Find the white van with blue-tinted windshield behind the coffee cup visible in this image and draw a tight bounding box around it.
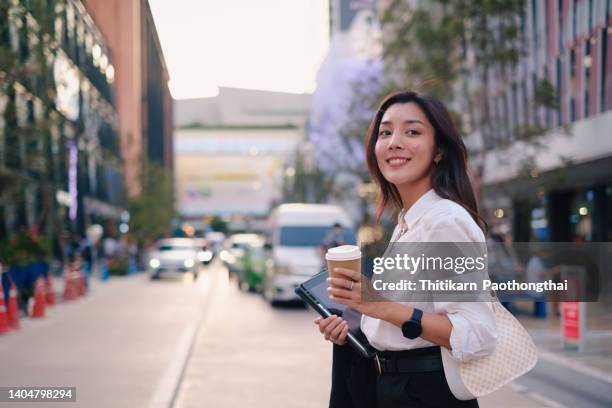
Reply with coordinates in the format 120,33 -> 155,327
263,204 -> 356,304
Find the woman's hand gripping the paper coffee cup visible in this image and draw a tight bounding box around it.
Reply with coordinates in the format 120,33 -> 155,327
327,268 -> 394,319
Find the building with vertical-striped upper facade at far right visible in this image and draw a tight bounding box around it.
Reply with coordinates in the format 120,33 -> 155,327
468,0 -> 612,242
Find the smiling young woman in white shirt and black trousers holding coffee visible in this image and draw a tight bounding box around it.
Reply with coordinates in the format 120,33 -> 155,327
315,92 -> 497,408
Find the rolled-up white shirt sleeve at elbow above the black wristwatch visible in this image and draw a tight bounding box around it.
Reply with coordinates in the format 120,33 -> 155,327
435,302 -> 497,362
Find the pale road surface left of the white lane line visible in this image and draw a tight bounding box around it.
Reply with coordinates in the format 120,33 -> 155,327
0,266 -> 206,407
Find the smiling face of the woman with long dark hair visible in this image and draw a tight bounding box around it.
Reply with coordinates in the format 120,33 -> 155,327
374,102 -> 439,186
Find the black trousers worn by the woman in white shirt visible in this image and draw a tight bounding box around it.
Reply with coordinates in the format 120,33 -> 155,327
329,345 -> 478,408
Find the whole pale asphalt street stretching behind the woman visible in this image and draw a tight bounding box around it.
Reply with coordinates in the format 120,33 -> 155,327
0,262 -> 609,408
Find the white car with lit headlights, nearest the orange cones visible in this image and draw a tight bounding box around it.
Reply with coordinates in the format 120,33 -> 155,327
147,238 -> 202,279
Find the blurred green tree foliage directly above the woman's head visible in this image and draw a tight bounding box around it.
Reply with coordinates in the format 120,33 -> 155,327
382,0 -> 525,124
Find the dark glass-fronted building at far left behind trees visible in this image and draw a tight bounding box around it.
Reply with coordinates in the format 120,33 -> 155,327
0,0 -> 127,239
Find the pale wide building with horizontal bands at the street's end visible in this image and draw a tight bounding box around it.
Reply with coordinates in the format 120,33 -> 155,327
174,87 -> 311,230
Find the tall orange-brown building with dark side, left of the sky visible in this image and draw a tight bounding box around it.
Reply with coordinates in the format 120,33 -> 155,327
85,0 -> 174,197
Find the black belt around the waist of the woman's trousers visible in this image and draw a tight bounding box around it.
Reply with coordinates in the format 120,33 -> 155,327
374,346 -> 444,374
